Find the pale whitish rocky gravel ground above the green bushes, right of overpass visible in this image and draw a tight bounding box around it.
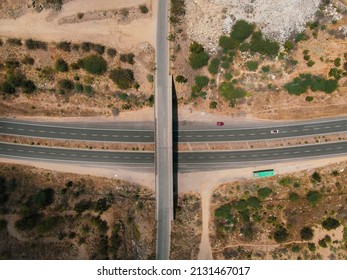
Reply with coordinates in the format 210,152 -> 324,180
186,0 -> 321,52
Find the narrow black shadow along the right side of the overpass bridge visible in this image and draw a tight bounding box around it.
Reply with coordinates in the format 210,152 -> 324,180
172,76 -> 179,219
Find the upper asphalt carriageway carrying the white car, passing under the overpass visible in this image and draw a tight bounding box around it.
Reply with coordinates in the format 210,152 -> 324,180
0,119 -> 347,143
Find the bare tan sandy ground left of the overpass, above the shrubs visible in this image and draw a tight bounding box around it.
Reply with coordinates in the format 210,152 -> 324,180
0,0 -> 157,49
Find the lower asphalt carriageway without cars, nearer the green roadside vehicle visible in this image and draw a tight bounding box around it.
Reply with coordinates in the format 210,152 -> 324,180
0,141 -> 347,172
